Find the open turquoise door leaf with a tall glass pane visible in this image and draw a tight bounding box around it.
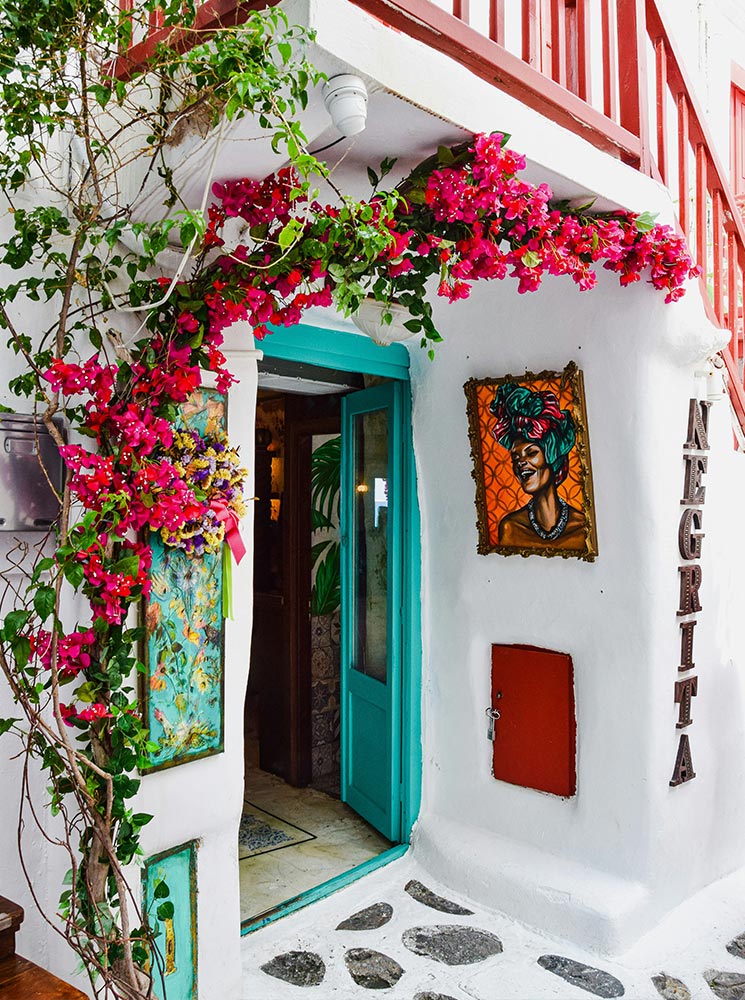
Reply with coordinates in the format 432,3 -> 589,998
341,382 -> 405,842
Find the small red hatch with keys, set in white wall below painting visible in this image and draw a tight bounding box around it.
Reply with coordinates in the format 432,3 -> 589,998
492,645 -> 577,797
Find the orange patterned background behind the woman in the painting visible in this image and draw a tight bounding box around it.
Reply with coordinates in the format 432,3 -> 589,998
473,375 -> 585,548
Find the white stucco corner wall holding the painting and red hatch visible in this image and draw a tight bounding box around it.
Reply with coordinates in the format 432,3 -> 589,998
404,264 -> 745,952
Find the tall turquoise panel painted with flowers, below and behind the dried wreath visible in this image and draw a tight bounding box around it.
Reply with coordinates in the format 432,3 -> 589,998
141,389 -> 227,772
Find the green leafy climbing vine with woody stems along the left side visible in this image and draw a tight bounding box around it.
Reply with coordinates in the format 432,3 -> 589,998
0,0 -> 332,1000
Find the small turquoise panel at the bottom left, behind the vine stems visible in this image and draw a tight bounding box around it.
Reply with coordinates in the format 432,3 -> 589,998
142,841 -> 197,1000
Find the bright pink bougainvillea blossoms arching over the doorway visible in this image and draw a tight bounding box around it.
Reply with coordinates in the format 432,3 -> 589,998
36,134 -> 698,724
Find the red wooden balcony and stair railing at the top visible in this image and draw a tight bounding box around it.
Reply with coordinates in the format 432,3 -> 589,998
118,0 -> 745,432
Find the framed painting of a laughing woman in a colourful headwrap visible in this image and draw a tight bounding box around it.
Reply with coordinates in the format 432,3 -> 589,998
463,362 -> 598,561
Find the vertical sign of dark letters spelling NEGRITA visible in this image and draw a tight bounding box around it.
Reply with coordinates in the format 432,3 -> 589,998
670,399 -> 711,785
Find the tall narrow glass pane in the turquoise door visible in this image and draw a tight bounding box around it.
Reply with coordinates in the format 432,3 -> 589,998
352,410 -> 388,684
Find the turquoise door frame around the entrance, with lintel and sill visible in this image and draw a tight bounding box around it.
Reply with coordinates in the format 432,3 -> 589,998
241,324 -> 422,934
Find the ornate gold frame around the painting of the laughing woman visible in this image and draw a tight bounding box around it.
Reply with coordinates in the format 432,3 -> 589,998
463,361 -> 598,562
